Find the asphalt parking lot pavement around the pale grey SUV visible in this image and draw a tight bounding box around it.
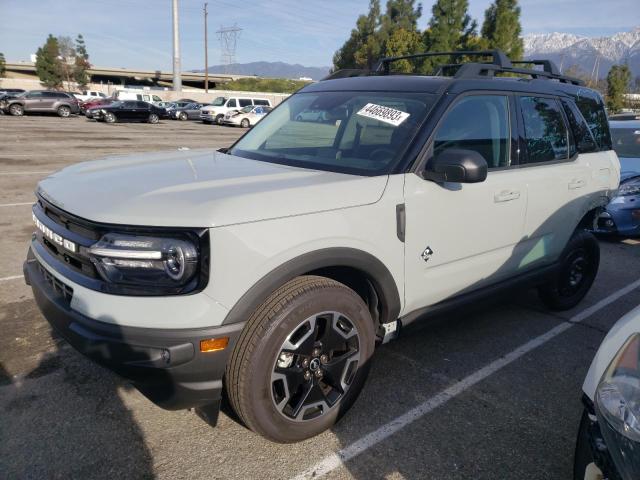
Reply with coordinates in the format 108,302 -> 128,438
0,116 -> 640,480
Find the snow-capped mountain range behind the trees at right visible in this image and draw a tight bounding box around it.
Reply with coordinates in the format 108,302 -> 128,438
523,26 -> 640,78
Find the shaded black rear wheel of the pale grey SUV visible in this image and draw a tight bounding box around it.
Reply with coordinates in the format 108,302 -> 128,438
538,230 -> 600,311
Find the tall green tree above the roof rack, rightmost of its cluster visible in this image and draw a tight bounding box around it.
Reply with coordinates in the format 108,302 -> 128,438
481,0 -> 524,60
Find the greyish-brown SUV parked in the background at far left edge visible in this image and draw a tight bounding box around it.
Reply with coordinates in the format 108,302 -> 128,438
0,90 -> 80,117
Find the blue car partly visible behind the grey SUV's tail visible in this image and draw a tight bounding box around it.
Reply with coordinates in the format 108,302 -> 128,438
595,120 -> 640,236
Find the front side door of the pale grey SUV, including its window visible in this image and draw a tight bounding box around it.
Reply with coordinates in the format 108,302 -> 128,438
405,93 -> 527,311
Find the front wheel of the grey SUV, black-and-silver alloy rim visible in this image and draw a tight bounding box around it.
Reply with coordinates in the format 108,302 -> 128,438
225,276 -> 375,443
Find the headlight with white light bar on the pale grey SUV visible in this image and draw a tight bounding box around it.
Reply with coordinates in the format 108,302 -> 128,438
88,233 -> 199,293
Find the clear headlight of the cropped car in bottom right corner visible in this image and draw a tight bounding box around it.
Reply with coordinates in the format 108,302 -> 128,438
596,334 -> 640,442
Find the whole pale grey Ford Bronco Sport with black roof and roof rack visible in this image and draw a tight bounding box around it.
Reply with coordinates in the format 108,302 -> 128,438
24,51 -> 620,442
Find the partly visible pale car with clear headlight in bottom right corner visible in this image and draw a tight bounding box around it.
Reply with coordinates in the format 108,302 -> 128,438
573,307 -> 640,480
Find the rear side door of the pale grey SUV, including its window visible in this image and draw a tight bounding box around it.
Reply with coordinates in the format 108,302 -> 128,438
516,94 -> 593,267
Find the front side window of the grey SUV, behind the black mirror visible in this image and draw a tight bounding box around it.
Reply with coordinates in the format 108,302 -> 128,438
433,95 -> 510,169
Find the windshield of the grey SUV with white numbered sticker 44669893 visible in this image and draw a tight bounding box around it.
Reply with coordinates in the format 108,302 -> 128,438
229,92 -> 433,175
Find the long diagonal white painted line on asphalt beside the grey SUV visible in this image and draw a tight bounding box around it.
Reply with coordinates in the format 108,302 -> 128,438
292,280 -> 640,480
